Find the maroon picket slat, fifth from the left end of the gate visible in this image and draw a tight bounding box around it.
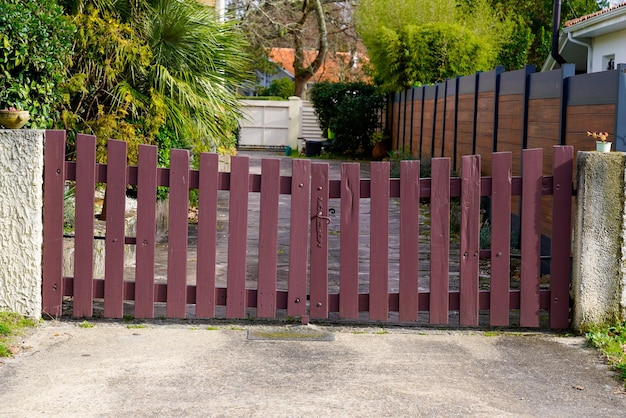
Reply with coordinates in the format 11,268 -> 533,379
167,149 -> 189,318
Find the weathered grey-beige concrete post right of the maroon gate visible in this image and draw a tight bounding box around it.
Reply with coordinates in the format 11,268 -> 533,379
572,152 -> 626,331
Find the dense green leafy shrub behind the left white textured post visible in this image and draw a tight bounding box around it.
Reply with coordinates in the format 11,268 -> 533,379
0,0 -> 75,128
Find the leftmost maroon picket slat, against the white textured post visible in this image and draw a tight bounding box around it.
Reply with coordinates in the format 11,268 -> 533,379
42,131 -> 65,318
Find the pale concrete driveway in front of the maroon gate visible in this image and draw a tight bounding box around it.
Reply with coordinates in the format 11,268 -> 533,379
0,321 -> 626,417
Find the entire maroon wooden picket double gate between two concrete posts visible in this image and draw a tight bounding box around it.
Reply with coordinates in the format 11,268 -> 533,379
43,131 -> 573,328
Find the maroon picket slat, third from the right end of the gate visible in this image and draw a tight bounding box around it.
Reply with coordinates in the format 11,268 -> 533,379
489,152 -> 512,326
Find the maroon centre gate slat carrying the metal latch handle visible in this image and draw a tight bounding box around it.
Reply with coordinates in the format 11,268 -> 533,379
309,163 -> 329,318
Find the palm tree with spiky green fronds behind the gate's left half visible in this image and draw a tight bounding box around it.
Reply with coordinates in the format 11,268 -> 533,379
63,0 -> 250,150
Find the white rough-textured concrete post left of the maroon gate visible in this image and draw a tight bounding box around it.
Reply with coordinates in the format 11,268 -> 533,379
0,129 -> 45,319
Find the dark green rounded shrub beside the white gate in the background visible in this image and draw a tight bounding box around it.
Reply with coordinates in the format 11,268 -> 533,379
311,82 -> 386,156
